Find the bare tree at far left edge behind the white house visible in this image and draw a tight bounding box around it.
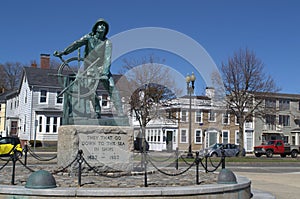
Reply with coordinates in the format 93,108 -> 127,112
0,62 -> 23,90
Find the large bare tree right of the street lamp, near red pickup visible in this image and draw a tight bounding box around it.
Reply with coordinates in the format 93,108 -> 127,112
221,48 -> 279,154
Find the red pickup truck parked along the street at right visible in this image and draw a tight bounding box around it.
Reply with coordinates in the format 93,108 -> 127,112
254,140 -> 299,158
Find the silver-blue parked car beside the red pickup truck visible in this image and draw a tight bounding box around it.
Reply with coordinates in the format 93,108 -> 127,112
200,143 -> 246,157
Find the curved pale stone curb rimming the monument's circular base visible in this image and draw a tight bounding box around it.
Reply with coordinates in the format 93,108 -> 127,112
0,177 -> 251,198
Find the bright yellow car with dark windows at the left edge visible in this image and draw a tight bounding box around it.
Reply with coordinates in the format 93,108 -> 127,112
0,137 -> 23,157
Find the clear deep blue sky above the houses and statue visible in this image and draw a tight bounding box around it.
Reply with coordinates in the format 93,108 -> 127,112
0,0 -> 300,94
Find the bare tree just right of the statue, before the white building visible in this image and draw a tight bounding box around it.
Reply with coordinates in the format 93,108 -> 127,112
122,55 -> 181,153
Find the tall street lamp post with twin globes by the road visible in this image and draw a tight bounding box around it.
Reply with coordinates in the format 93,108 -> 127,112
186,73 -> 196,158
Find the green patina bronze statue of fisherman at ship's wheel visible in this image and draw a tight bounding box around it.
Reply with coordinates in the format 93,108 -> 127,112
54,19 -> 123,125
